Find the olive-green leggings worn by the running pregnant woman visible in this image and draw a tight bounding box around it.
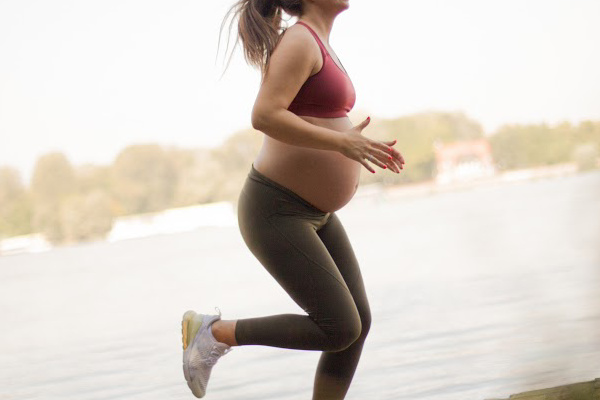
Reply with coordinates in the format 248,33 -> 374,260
235,165 -> 371,400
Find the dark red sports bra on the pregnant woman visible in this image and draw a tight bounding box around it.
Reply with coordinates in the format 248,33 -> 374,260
288,21 -> 356,118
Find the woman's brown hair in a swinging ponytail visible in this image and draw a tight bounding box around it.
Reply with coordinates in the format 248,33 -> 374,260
217,0 -> 303,77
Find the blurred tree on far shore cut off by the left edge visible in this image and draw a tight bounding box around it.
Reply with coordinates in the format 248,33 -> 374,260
0,166 -> 32,238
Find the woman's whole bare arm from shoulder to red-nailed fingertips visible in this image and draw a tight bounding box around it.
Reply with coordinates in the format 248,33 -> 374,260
252,26 -> 404,172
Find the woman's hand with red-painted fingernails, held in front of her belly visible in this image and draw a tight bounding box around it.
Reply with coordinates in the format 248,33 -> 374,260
339,117 -> 404,174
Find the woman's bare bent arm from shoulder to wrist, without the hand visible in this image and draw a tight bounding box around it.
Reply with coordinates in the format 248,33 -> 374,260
252,26 -> 344,151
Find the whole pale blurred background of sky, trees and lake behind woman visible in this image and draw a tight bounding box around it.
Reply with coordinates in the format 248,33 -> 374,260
0,0 -> 600,400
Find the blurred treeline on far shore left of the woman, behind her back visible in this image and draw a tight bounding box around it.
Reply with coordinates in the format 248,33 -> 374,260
0,130 -> 262,245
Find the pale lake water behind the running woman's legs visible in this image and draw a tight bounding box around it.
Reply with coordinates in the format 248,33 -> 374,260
0,171 -> 600,400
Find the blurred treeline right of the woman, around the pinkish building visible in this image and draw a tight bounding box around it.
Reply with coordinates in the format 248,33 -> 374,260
361,112 -> 600,185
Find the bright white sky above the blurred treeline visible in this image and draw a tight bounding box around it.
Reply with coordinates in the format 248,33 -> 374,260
0,0 -> 600,182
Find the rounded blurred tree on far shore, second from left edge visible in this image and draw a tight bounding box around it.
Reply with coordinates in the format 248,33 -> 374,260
31,152 -> 77,244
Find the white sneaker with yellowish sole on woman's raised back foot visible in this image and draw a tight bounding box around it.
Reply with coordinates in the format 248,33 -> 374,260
181,310 -> 231,398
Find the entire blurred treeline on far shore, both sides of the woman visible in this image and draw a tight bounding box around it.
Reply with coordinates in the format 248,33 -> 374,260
0,112 -> 600,244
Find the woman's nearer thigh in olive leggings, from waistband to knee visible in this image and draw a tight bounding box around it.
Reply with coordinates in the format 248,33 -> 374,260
238,178 -> 360,330
